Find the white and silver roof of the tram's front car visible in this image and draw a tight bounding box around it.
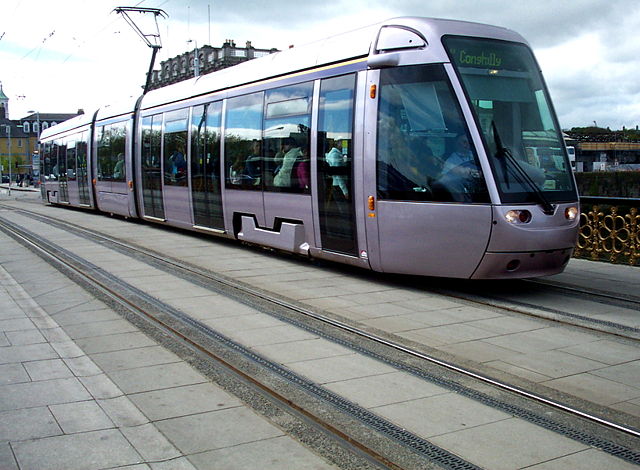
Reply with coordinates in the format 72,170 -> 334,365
142,17 -> 526,109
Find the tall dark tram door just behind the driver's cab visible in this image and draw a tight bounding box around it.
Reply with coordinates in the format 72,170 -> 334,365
317,74 -> 358,256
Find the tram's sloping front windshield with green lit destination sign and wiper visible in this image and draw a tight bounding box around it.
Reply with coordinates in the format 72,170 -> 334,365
444,36 -> 576,207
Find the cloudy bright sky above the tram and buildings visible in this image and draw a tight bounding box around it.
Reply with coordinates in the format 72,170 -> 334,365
0,0 -> 640,129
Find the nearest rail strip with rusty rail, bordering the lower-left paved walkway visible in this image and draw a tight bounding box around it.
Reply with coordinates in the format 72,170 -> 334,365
0,210 -> 479,470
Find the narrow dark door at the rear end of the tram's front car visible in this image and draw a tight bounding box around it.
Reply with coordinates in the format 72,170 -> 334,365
140,114 -> 164,220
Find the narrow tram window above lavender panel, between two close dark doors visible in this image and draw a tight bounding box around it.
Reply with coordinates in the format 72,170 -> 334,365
164,108 -> 189,186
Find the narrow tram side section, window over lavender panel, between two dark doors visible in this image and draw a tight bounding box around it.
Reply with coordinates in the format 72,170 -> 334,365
162,108 -> 192,226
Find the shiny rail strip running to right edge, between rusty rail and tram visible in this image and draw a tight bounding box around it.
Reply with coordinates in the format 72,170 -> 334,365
3,204 -> 640,468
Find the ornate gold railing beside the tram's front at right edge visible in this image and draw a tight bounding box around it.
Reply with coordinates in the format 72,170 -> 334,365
573,197 -> 640,266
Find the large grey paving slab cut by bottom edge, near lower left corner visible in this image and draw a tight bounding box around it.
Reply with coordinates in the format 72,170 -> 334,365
13,429 -> 143,470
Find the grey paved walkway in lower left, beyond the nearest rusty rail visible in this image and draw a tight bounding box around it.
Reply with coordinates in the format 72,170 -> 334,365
0,231 -> 333,470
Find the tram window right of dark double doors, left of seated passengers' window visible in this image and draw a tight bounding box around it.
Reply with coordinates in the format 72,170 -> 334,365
224,92 -> 264,190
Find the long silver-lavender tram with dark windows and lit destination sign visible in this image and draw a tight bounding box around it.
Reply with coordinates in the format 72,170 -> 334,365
41,17 -> 580,279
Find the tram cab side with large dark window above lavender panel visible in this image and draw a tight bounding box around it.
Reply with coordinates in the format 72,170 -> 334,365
363,65 -> 491,277
